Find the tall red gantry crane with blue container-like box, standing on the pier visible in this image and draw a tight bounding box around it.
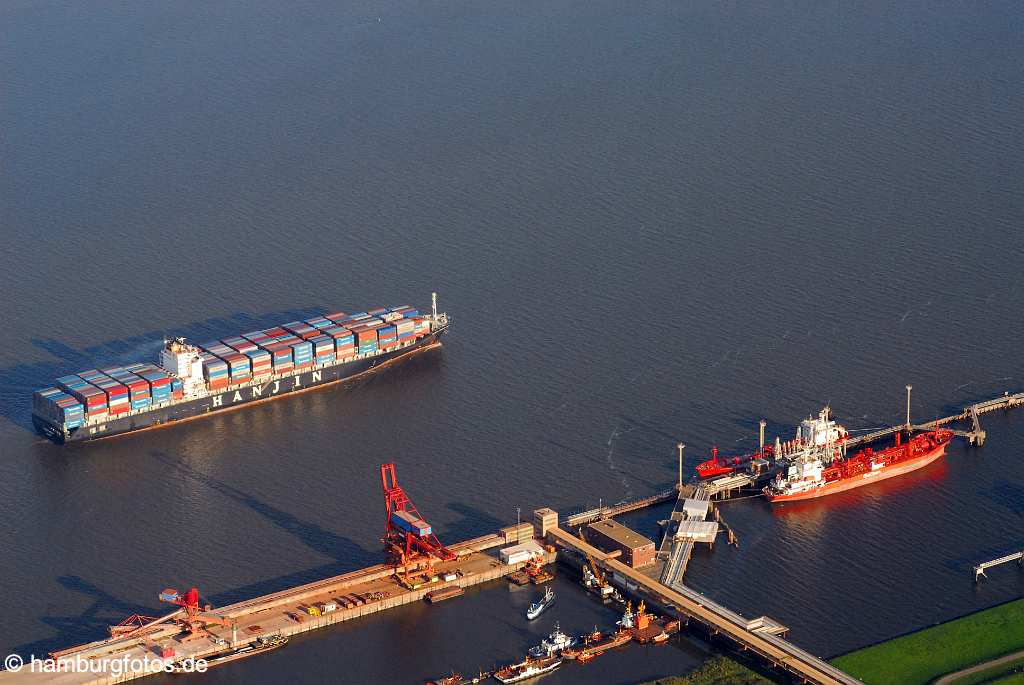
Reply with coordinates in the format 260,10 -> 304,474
381,464 -> 457,585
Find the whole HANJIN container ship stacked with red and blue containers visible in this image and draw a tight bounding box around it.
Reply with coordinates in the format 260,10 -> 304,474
32,294 -> 450,444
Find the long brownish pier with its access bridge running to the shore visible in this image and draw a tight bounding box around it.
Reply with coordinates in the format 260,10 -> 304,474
0,485 -> 859,685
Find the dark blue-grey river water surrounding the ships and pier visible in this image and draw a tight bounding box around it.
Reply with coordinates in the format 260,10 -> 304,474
0,0 -> 1024,683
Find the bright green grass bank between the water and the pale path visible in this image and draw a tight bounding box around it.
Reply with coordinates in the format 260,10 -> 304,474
833,599 -> 1024,685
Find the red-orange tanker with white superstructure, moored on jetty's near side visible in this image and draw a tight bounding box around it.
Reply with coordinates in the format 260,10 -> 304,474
764,429 -> 953,502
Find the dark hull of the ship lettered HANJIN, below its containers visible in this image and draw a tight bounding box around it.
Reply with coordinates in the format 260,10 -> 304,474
32,329 -> 446,444
